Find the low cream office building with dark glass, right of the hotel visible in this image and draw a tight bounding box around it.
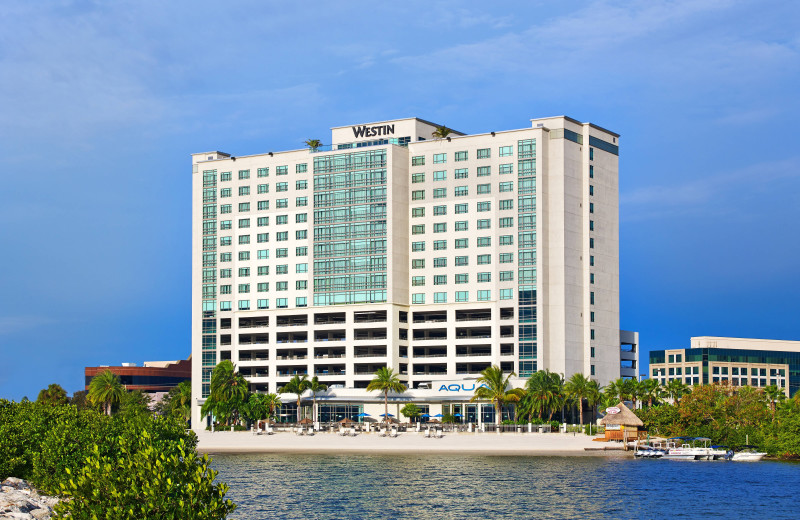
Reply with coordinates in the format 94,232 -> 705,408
650,336 -> 800,396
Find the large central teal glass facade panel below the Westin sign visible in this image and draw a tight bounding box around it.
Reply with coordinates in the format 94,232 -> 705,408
314,149 -> 388,305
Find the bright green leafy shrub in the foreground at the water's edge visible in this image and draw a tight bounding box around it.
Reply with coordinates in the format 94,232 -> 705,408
55,431 -> 231,520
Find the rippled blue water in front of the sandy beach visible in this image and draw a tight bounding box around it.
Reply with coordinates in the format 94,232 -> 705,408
214,454 -> 800,520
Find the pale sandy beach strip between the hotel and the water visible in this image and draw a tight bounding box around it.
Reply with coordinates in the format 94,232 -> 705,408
196,431 -> 630,456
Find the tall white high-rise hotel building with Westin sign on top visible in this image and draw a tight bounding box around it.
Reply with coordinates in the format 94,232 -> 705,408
192,117 -> 638,427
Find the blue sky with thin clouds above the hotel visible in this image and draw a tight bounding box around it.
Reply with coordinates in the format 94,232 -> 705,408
0,0 -> 800,399
